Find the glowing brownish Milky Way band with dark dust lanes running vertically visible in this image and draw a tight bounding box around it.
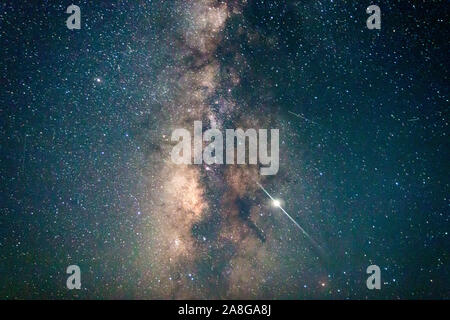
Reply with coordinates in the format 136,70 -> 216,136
135,1 -> 308,298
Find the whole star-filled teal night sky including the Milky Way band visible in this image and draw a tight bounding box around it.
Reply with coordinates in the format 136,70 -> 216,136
0,0 -> 450,299
